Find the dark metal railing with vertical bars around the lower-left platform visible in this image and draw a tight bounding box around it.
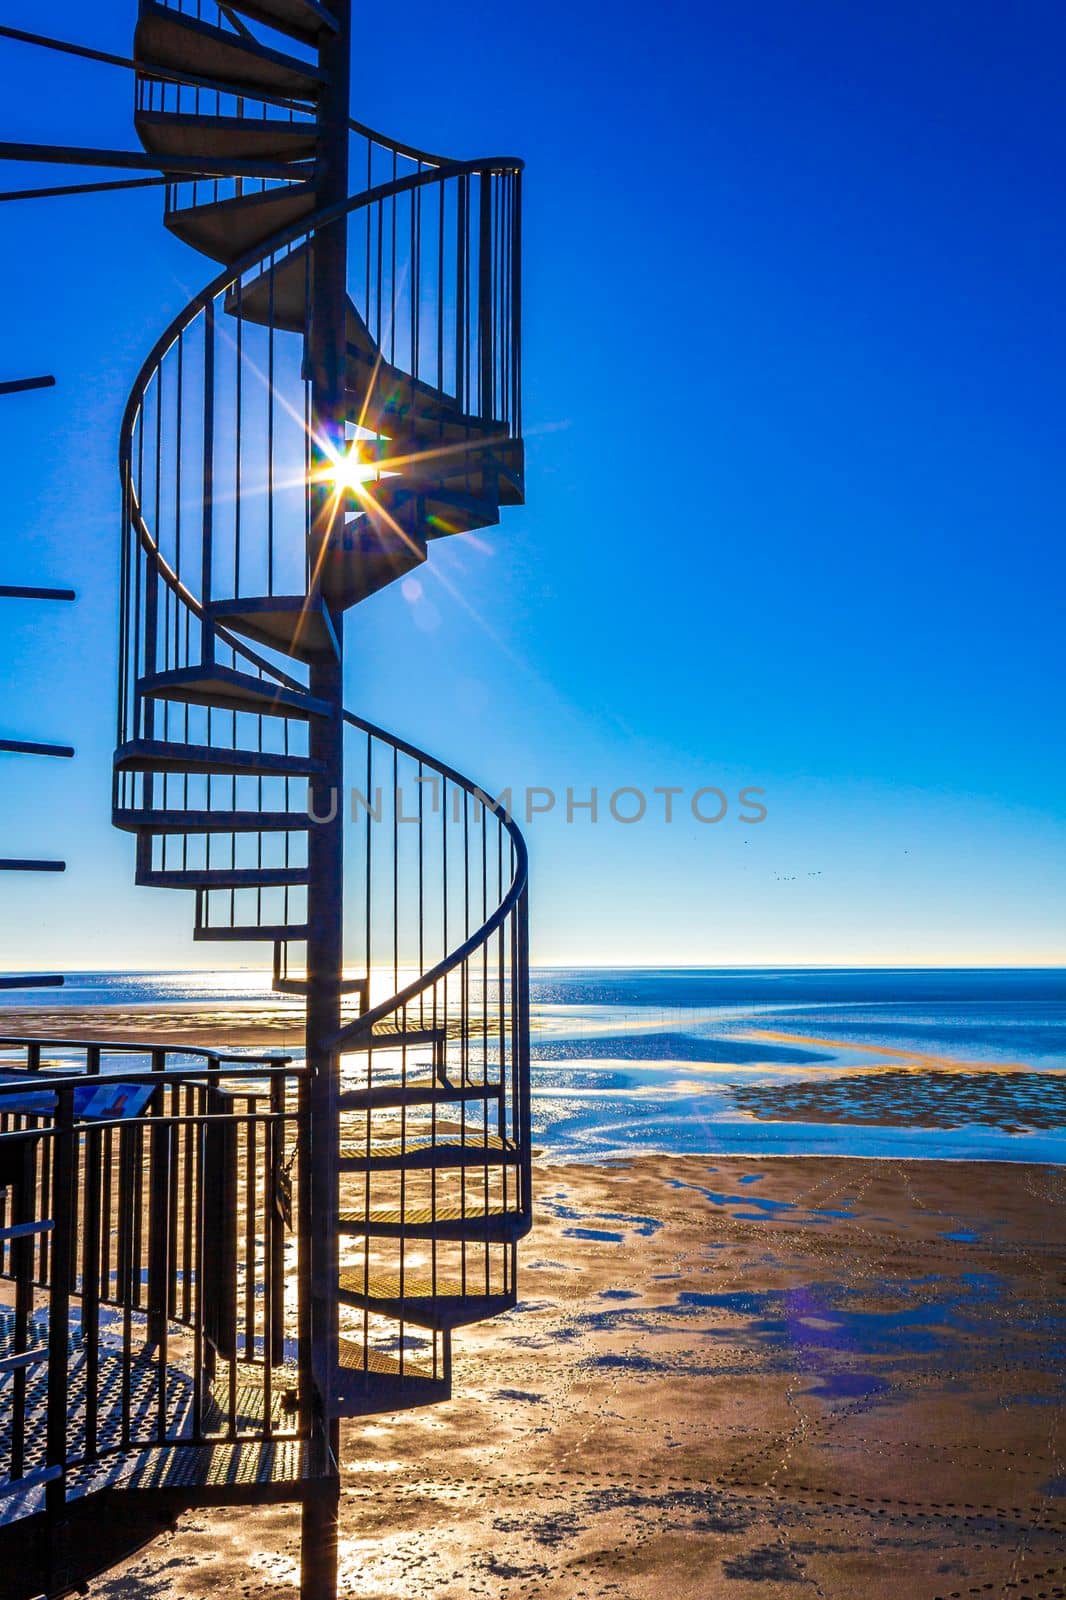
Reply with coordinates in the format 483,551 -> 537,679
0,1038 -> 312,1522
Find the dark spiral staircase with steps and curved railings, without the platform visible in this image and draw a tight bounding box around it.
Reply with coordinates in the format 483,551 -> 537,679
112,0 -> 530,1497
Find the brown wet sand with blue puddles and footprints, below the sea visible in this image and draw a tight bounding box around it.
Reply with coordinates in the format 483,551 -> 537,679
94,1157 -> 1066,1600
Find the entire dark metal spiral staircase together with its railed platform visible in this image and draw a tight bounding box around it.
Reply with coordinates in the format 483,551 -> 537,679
0,0 -> 531,1600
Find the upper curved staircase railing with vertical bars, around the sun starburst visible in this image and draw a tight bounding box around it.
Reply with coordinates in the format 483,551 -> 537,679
114,162 -> 520,953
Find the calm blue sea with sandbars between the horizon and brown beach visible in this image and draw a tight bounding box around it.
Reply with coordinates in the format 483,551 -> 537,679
3,968 -> 1066,1162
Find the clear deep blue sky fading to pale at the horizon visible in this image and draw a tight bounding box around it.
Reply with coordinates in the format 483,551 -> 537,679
0,0 -> 1066,968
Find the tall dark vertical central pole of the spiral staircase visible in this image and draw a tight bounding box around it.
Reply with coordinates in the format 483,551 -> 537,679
301,0 -> 352,1600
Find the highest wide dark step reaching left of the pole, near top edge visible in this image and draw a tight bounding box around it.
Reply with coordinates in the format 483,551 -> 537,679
133,0 -> 323,101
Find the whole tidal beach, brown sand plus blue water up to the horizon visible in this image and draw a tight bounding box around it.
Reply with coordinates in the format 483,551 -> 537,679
0,978 -> 1066,1600
